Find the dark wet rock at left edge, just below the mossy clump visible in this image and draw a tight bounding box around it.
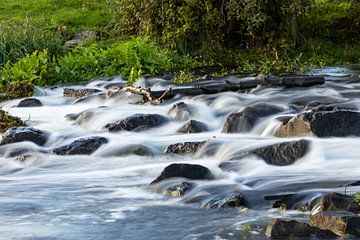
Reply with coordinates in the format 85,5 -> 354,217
0,127 -> 47,146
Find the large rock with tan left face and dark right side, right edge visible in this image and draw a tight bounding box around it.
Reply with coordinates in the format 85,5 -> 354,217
275,111 -> 360,137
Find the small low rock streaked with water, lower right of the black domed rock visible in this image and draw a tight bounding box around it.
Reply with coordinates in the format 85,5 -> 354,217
204,193 -> 245,208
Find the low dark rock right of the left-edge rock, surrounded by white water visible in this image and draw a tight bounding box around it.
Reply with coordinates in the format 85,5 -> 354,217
53,137 -> 108,155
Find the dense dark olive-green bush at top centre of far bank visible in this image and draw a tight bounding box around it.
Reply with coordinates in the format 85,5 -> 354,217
112,0 -> 312,52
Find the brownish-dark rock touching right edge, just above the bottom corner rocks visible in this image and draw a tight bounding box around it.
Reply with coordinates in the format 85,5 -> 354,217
310,193 -> 360,214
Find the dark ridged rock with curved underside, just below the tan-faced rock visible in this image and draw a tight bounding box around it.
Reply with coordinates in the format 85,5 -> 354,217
252,140 -> 310,166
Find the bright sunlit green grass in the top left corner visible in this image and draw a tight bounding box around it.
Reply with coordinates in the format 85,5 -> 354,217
0,0 -> 112,31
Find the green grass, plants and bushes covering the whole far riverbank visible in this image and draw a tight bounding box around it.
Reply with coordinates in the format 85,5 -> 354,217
0,0 -> 360,96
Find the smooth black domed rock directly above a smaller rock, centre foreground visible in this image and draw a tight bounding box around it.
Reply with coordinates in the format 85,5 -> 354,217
150,163 -> 212,184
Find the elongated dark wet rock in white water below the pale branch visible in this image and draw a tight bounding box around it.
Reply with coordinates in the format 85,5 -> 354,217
104,114 -> 169,132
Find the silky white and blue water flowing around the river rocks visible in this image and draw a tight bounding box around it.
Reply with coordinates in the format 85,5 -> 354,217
0,68 -> 360,240
